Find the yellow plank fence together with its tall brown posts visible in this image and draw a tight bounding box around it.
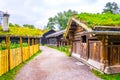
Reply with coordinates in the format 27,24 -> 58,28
0,36 -> 39,76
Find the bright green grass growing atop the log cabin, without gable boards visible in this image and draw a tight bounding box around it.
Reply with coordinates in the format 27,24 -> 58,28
76,13 -> 120,27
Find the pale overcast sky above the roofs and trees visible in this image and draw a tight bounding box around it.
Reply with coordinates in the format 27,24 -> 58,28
0,0 -> 120,28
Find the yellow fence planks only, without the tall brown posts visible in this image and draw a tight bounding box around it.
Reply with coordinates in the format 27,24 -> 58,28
0,44 -> 39,76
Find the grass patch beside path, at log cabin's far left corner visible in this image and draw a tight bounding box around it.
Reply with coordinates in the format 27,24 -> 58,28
49,46 -> 71,57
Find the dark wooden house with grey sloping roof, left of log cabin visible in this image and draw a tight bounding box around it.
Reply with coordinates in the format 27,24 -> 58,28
46,30 -> 67,46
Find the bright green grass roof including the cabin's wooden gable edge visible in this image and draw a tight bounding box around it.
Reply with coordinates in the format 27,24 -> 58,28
64,13 -> 120,37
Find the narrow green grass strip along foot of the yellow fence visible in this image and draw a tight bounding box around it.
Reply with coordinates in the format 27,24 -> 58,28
0,50 -> 41,80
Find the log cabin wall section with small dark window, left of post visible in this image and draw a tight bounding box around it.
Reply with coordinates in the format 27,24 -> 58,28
72,26 -> 88,60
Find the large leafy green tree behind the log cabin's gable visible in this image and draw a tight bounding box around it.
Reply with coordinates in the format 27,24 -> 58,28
46,10 -> 77,30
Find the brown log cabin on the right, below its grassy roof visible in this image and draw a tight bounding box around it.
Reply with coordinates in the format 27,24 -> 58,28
64,14 -> 120,74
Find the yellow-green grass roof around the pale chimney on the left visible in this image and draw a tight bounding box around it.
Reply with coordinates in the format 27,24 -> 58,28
0,26 -> 45,36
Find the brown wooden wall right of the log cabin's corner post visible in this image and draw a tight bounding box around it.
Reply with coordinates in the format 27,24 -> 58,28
106,36 -> 120,66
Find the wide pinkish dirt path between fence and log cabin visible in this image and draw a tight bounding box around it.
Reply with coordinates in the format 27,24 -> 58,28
15,46 -> 100,80
